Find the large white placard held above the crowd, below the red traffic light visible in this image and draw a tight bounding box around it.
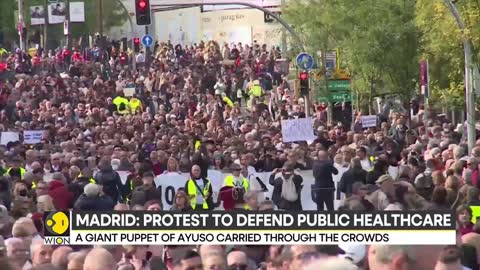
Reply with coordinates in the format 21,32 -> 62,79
282,118 -> 316,143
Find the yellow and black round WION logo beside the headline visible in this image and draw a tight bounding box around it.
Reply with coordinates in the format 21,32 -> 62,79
43,212 -> 70,245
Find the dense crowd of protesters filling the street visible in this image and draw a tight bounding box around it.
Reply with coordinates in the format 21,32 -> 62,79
0,34 -> 480,270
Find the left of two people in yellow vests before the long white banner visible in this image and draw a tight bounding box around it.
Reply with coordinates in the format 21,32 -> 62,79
185,165 -> 213,210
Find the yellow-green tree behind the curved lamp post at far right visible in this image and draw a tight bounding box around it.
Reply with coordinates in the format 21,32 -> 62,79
415,0 -> 480,110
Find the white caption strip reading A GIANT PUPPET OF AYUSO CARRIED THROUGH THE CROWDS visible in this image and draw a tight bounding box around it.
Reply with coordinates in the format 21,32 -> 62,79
65,231 -> 456,245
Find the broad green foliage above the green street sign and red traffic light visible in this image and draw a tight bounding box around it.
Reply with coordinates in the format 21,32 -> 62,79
285,0 -> 419,112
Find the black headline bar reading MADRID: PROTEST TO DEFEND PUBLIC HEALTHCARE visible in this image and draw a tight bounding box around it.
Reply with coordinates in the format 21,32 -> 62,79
71,211 -> 456,231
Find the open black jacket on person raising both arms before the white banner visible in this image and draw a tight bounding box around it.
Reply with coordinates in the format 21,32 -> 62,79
268,173 -> 303,211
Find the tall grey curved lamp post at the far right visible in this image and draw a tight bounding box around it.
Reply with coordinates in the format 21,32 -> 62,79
444,0 -> 476,153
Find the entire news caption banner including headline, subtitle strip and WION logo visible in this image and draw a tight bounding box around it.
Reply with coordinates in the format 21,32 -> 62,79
44,211 -> 456,245
